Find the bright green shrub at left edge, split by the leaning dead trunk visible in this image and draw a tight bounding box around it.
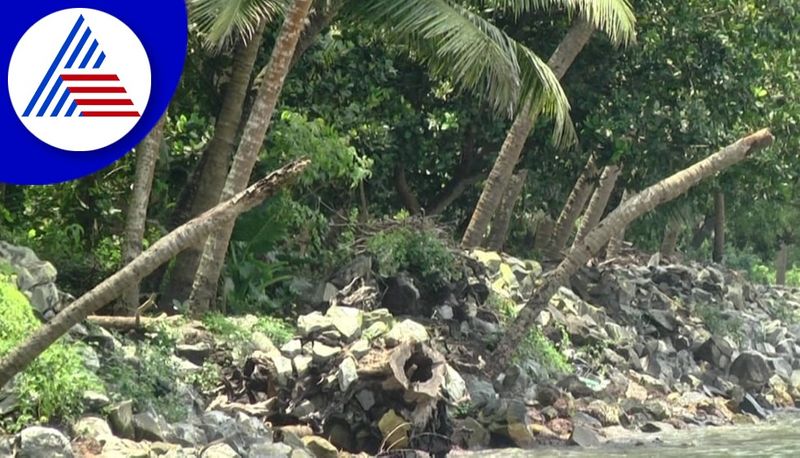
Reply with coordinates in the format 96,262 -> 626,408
0,276 -> 104,432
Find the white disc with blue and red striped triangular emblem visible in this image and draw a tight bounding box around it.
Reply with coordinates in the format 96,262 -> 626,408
8,8 -> 151,152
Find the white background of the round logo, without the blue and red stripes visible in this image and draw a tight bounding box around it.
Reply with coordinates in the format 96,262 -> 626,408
8,8 -> 151,151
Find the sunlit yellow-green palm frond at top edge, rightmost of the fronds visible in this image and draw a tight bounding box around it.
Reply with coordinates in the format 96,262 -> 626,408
482,0 -> 636,45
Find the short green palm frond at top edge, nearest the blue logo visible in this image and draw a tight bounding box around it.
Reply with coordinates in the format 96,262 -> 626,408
186,0 -> 286,49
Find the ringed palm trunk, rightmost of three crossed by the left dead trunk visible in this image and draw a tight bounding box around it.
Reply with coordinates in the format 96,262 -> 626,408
189,0 -> 312,315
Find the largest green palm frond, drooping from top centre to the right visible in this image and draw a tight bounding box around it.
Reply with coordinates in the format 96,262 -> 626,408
345,0 -> 574,144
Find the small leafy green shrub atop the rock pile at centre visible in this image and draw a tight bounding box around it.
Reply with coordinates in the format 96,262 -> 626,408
367,227 -> 460,288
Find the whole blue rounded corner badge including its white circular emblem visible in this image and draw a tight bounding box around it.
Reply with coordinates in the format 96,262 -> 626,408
0,0 -> 187,184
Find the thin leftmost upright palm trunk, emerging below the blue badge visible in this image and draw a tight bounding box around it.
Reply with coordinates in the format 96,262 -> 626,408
117,114 -> 166,315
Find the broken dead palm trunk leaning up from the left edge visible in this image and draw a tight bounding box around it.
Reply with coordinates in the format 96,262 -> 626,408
0,160 -> 309,388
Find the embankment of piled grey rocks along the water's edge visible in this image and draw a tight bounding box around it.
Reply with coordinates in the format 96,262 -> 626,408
0,242 -> 800,457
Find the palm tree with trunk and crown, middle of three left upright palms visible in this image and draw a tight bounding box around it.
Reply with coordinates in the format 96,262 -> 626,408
163,0 -> 286,304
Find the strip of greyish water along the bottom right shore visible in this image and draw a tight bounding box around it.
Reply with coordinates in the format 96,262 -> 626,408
454,415 -> 800,458
